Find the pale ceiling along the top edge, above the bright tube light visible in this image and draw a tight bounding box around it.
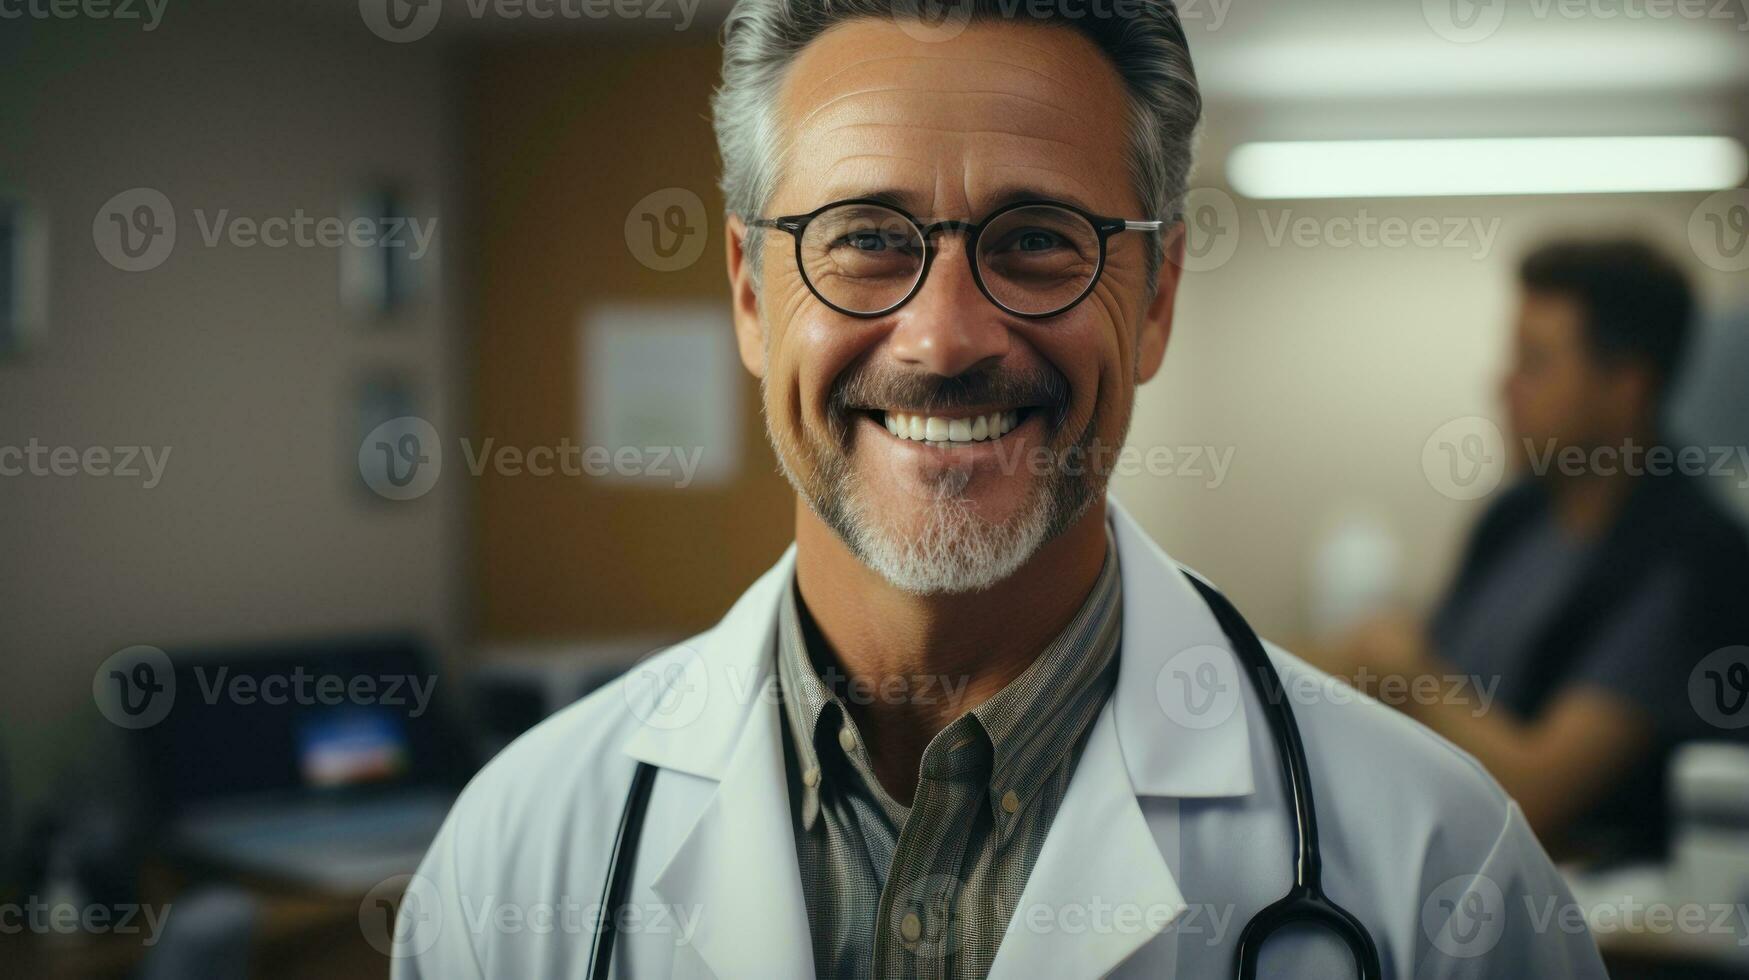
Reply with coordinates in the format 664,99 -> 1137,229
286,0 -> 1749,144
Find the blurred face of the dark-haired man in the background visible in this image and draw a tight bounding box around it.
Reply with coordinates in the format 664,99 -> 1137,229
1504,292 -> 1639,464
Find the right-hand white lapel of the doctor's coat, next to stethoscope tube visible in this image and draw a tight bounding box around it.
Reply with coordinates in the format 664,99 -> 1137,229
990,501 -> 1256,980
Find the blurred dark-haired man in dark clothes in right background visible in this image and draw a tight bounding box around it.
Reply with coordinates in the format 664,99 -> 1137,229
1324,240 -> 1749,861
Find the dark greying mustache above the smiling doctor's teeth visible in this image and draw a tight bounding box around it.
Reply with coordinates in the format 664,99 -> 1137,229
827,358 -> 1069,424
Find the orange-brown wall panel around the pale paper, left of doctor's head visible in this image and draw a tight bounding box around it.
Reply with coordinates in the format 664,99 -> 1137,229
465,32 -> 792,642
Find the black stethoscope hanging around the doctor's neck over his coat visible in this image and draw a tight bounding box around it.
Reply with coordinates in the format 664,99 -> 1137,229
589,574 -> 1383,980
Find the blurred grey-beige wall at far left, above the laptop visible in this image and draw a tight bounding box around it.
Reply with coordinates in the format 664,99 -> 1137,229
0,4 -> 467,819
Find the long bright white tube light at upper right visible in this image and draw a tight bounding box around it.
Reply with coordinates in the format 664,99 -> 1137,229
1226,137 -> 1749,200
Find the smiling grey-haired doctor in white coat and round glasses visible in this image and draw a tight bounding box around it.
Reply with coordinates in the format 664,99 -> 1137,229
395,0 -> 1604,978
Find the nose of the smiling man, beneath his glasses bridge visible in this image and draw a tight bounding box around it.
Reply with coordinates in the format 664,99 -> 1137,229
888,238 -> 1009,378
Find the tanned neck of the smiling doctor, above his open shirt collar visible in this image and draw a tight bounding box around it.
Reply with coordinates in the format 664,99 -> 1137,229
796,499 -> 1105,802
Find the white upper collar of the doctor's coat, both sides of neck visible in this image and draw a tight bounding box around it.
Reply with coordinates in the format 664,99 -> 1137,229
626,499 -> 1256,798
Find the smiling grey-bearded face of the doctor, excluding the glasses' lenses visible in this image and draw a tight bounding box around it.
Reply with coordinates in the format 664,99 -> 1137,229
731,19 -> 1175,592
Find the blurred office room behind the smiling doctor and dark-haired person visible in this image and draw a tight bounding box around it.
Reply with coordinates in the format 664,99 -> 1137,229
0,0 -> 1749,980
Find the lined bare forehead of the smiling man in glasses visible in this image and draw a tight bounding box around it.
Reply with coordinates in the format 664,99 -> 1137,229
780,19 -> 1133,214
